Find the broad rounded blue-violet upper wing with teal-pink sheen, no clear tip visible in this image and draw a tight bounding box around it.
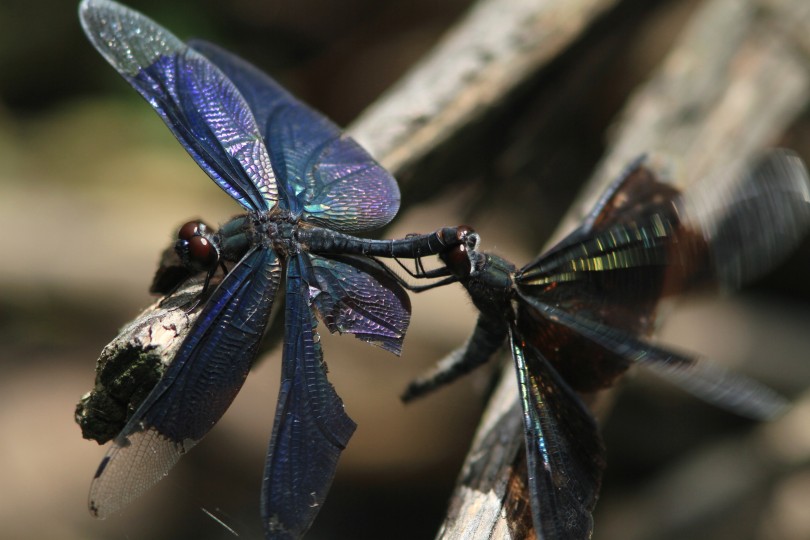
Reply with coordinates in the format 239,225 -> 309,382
190,41 -> 399,232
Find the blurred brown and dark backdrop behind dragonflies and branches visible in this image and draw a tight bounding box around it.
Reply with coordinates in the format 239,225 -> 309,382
0,0 -> 810,539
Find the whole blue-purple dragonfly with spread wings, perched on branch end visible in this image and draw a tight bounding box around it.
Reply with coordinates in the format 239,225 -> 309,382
79,0 -> 464,538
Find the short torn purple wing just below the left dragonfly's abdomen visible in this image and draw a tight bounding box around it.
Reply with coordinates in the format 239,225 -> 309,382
302,254 -> 411,354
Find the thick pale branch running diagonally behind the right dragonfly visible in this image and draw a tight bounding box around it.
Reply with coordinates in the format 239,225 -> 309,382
438,0 -> 810,539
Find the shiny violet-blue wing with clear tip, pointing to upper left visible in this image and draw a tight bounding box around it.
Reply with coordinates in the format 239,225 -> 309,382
79,0 -> 278,210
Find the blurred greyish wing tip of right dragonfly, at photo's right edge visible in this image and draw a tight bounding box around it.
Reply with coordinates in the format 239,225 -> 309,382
679,149 -> 810,288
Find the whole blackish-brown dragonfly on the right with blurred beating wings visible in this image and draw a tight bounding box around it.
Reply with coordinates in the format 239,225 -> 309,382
403,151 -> 810,540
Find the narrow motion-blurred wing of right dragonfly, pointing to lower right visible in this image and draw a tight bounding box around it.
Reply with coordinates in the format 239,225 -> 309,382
521,295 -> 787,419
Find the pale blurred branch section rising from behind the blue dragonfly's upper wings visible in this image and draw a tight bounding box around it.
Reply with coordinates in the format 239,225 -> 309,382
349,0 -> 617,175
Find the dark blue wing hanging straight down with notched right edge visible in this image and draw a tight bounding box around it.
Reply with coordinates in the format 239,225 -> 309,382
262,255 -> 356,539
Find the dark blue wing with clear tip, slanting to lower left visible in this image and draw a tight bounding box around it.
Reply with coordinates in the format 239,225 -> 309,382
90,247 -> 281,517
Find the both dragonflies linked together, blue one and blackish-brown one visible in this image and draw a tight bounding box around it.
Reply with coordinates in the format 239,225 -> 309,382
74,0 -> 810,539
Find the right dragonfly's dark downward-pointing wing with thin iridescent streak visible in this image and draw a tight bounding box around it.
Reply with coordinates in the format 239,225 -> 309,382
510,329 -> 605,540
